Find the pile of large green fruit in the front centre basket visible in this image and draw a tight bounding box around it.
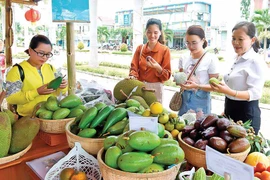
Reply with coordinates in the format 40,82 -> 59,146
104,130 -> 185,173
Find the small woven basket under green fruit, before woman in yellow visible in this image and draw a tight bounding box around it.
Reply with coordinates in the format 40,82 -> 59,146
38,118 -> 75,134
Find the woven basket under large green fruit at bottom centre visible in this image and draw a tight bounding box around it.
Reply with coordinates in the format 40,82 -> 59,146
97,148 -> 181,180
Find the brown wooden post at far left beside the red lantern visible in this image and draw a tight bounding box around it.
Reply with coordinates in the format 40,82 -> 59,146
5,0 -> 13,67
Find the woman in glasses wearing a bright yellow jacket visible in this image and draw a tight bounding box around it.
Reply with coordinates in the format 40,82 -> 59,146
6,35 -> 67,116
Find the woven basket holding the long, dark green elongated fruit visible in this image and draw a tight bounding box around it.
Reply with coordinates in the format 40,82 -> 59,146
66,121 -> 104,155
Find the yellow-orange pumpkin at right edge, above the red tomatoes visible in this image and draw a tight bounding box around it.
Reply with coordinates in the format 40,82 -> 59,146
245,152 -> 269,167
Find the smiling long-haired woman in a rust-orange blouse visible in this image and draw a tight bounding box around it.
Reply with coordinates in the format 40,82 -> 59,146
129,18 -> 171,102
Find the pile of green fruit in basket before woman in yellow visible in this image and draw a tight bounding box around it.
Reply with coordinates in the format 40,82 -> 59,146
35,94 -> 86,120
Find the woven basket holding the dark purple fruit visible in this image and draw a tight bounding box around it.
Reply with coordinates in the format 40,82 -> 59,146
178,132 -> 250,169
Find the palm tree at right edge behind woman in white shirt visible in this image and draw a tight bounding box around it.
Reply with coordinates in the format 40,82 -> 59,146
251,8 -> 270,60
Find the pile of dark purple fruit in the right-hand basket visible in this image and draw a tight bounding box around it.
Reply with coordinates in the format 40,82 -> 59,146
182,114 -> 250,153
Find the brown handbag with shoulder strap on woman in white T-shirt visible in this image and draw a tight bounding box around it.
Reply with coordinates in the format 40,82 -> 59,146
169,51 -> 207,111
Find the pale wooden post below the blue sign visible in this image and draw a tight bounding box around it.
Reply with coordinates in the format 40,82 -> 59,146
66,22 -> 76,94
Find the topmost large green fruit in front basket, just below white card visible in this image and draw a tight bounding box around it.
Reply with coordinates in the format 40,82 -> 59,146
128,131 -> 160,152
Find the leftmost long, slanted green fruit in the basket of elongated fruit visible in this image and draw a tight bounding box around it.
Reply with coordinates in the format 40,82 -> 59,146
79,106 -> 98,129
